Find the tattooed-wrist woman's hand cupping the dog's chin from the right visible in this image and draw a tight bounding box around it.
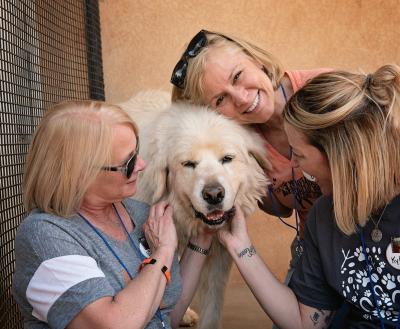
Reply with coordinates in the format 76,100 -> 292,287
217,205 -> 251,252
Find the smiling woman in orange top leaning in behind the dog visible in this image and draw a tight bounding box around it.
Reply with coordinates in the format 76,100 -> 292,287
171,30 -> 329,282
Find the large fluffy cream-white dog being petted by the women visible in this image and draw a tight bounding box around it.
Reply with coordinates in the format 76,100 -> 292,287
119,91 -> 270,329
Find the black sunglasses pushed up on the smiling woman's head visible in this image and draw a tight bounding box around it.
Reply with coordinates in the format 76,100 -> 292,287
171,30 -> 209,89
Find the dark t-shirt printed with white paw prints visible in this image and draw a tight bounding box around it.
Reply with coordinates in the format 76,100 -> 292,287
289,196 -> 400,329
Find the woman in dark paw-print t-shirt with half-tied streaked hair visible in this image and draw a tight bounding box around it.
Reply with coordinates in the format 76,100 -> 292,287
219,65 -> 400,329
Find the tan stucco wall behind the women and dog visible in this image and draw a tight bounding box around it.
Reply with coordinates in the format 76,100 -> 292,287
100,0 -> 400,280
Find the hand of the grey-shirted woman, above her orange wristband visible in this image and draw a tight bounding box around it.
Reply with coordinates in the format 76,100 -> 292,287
143,201 -> 178,253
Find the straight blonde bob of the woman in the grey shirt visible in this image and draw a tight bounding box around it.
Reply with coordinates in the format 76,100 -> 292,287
23,101 -> 137,217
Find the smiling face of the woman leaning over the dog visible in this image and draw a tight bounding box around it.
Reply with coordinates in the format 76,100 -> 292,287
202,48 -> 275,124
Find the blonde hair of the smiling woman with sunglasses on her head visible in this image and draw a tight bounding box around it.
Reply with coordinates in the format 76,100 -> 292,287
172,31 -> 284,105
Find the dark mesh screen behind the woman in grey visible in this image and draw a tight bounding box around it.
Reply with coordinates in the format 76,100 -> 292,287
0,0 -> 104,329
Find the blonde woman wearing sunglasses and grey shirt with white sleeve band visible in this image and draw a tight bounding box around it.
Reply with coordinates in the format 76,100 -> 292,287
13,101 -> 212,329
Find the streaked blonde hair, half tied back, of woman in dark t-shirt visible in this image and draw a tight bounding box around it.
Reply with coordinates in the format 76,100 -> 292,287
284,65 -> 400,235
